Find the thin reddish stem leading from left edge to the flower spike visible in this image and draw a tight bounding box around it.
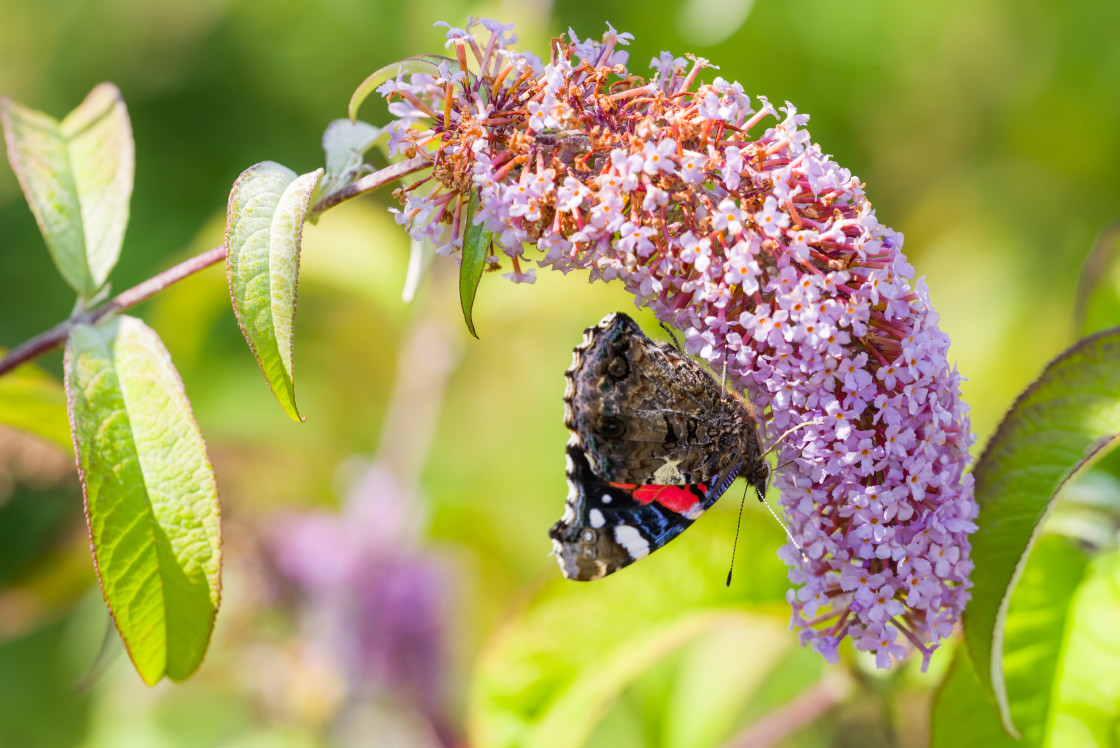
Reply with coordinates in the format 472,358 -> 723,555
0,156 -> 431,376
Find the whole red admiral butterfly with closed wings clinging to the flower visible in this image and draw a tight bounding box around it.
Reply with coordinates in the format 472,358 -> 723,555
549,312 -> 769,581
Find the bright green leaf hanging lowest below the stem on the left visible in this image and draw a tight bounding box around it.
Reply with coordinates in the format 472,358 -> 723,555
64,317 -> 222,684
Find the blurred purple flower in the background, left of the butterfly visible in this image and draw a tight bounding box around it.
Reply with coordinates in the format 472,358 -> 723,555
268,464 -> 454,745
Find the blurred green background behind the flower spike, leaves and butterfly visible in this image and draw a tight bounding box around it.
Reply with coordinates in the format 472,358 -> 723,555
0,0 -> 1120,748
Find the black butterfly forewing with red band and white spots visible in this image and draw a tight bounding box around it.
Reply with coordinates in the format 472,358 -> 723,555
549,442 -> 734,581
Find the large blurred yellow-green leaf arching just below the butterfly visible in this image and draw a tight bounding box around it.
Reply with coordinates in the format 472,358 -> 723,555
468,512 -> 796,748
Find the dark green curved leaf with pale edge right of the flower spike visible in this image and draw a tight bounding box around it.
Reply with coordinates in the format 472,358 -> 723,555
964,328 -> 1120,730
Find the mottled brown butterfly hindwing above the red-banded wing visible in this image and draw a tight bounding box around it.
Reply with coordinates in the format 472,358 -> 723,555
564,312 -> 755,486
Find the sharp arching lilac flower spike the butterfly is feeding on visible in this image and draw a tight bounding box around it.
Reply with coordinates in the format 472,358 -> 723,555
381,20 -> 977,667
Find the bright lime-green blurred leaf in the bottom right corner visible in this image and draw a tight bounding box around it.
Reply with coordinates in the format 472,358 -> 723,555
1046,552 -> 1120,748
